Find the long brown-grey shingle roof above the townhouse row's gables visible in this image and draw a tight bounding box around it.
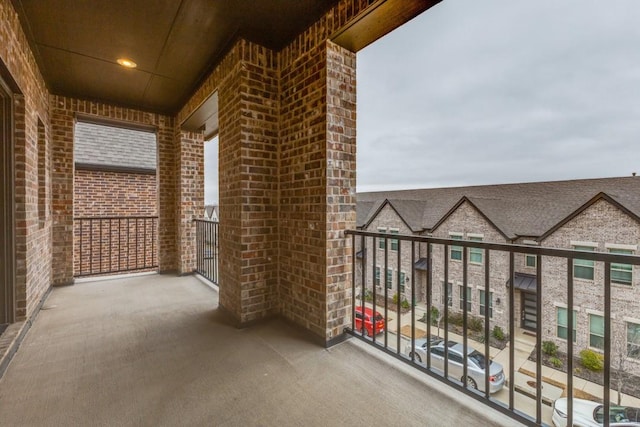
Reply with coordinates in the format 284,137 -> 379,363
357,177 -> 640,238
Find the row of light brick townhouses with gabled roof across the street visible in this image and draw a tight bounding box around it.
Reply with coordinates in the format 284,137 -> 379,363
356,177 -> 640,368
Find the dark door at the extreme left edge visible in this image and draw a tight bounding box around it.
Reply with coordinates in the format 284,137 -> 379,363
0,78 -> 14,325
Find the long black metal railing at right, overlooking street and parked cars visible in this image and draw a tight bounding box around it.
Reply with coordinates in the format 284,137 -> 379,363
346,230 -> 640,425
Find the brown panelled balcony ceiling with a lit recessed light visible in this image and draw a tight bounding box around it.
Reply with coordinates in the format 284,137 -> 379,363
12,0 -> 337,114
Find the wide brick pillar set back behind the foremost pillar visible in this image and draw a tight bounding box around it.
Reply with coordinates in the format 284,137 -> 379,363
218,40 -> 278,325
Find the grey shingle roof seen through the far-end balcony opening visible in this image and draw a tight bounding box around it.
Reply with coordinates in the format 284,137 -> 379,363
73,122 -> 156,170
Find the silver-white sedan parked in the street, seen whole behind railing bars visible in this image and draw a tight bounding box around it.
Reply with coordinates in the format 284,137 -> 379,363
405,338 -> 505,393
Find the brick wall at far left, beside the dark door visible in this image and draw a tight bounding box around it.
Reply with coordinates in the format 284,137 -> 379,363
0,0 -> 52,320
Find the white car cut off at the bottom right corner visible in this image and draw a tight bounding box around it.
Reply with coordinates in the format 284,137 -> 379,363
551,397 -> 640,427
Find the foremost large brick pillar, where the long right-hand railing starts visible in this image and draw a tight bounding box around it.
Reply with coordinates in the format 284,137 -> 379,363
280,41 -> 356,343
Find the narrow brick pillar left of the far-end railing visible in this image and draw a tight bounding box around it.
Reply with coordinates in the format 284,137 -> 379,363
51,96 -> 74,286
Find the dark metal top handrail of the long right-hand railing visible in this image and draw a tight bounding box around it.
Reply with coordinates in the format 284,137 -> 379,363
345,230 -> 640,265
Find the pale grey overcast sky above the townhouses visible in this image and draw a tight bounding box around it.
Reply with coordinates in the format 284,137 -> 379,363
205,0 -> 640,203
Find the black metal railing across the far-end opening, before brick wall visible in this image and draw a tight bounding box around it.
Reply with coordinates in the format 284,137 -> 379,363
73,216 -> 158,277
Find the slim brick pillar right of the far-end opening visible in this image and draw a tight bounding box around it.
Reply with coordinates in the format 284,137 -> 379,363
176,131 -> 204,274
